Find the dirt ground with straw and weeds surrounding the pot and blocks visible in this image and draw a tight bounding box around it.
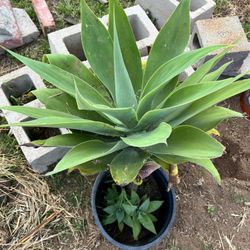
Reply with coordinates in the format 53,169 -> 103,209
0,0 -> 250,250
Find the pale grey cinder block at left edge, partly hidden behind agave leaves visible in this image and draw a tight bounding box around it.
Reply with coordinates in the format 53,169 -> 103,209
0,67 -> 69,173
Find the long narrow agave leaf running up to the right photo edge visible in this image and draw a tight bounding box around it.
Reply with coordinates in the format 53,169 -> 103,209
169,79 -> 250,127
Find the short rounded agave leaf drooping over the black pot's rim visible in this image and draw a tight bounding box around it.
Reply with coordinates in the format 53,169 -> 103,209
110,148 -> 147,185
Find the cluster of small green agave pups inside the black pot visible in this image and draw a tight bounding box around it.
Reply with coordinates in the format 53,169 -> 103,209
102,185 -> 163,240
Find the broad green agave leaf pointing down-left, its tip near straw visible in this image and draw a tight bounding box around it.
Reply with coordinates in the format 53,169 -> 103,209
46,140 -> 126,175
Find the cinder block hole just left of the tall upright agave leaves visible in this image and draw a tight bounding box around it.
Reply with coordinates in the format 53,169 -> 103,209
63,32 -> 87,61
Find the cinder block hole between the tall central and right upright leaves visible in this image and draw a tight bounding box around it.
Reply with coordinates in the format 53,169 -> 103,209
128,15 -> 150,41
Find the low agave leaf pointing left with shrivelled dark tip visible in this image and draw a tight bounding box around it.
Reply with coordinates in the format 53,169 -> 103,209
31,133 -> 93,148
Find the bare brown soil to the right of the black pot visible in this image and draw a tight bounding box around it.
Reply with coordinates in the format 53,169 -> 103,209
156,96 -> 250,250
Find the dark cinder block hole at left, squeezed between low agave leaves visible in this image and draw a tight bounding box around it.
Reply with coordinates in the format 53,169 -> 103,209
22,118 -> 61,141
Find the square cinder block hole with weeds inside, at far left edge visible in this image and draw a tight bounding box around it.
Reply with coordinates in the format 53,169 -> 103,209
2,75 -> 36,105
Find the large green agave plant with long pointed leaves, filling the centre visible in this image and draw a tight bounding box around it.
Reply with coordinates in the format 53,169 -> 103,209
2,0 -> 250,184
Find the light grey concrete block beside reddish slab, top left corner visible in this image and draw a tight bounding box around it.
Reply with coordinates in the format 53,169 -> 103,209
13,8 -> 40,44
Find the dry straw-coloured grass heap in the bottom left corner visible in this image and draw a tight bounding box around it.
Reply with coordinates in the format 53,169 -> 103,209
0,155 -> 94,250
